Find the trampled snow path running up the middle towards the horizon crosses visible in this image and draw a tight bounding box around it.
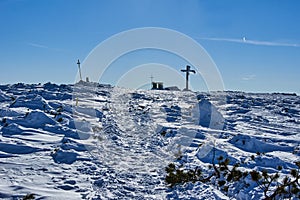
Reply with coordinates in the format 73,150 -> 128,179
89,89 -> 168,199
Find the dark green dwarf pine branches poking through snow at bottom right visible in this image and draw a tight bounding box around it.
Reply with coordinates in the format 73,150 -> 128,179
165,156 -> 300,200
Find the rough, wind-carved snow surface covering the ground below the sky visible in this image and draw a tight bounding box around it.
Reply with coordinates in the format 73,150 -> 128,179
0,83 -> 300,199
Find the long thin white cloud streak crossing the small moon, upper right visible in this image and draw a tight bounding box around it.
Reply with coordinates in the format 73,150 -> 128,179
199,37 -> 300,47
